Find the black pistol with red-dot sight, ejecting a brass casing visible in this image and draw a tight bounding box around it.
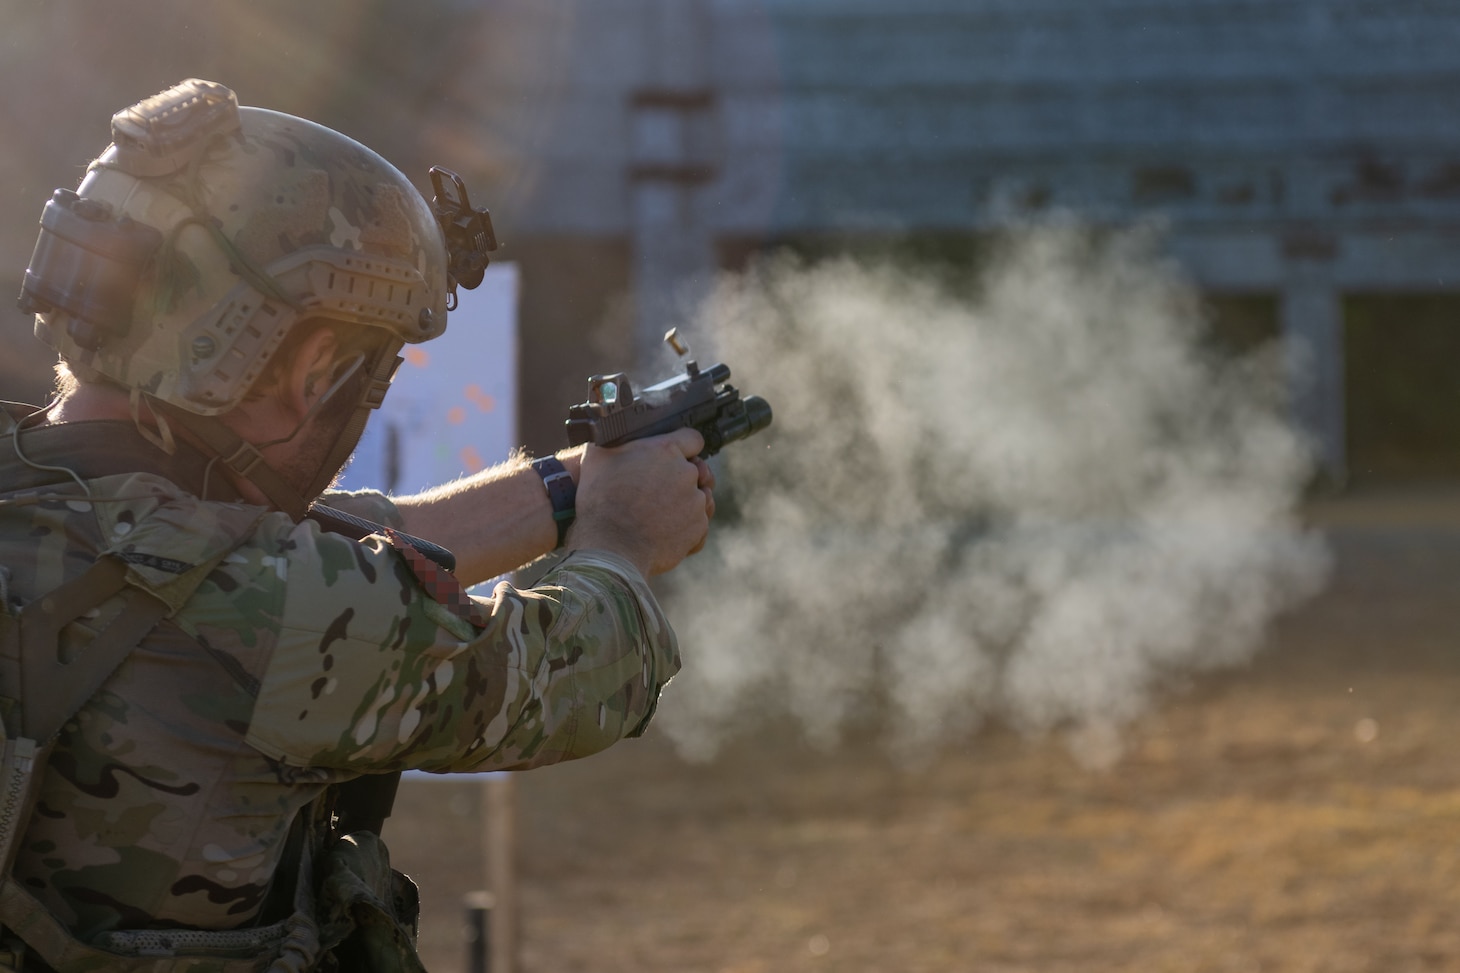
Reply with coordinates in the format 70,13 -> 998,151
565,329 -> 771,459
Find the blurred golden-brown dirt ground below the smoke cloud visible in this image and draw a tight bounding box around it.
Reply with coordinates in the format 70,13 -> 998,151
387,491 -> 1460,973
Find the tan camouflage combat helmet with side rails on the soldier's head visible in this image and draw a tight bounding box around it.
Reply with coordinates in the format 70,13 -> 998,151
20,79 -> 448,415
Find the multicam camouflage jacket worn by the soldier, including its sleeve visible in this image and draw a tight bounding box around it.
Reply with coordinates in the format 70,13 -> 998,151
0,416 -> 679,939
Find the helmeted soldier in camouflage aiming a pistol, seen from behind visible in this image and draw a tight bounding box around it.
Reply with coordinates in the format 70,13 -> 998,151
0,80 -> 714,973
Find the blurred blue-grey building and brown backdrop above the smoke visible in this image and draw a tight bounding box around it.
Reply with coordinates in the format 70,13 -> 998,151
8,0 -> 1460,482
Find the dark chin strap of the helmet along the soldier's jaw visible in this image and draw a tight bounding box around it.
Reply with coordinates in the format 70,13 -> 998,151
150,342 -> 400,522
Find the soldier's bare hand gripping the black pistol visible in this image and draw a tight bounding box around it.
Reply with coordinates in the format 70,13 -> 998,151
568,430 -> 715,576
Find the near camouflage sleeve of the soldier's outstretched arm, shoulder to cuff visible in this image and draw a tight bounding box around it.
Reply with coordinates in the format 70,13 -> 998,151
237,523 -> 679,771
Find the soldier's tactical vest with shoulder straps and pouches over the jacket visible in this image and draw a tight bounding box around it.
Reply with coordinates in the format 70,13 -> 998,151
0,416 -> 423,973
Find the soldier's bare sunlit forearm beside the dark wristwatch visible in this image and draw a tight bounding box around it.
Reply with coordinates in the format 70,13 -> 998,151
396,450 -> 583,584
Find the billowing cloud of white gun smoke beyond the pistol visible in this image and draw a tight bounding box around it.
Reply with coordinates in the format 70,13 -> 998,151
660,219 -> 1329,764
